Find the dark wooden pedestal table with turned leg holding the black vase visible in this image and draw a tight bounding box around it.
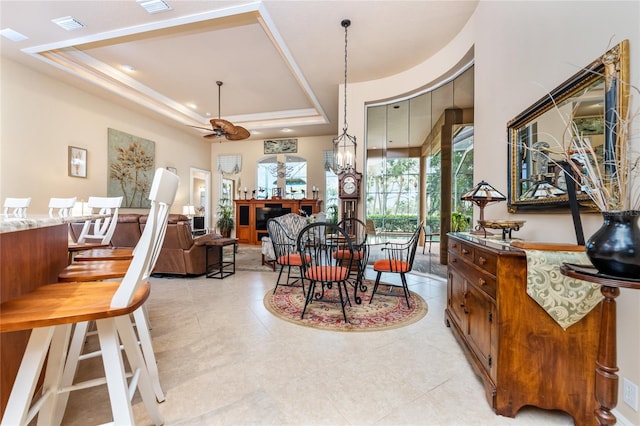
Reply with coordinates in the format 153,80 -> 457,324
560,263 -> 640,425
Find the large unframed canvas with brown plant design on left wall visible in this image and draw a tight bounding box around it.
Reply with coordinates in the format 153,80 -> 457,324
107,129 -> 156,208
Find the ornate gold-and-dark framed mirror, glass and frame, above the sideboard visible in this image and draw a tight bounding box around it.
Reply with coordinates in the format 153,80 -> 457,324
507,40 -> 629,213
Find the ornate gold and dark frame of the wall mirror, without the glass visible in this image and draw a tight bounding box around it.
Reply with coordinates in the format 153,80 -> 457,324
507,40 -> 629,213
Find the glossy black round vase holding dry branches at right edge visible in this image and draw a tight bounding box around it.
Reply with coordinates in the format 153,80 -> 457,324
586,210 -> 640,278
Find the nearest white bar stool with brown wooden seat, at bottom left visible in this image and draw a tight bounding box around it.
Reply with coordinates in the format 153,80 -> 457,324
0,169 -> 179,425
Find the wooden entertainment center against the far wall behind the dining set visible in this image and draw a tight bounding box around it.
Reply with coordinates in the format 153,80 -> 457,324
234,198 -> 322,245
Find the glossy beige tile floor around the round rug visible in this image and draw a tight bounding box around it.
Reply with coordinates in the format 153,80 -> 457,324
63,271 -> 573,425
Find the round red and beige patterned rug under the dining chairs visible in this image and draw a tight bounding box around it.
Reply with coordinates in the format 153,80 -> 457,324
264,280 -> 428,331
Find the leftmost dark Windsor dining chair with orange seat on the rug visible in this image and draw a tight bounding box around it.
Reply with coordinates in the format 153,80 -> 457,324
267,218 -> 306,295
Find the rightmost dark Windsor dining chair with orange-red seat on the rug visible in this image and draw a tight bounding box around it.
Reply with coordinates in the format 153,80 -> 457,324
369,223 -> 422,308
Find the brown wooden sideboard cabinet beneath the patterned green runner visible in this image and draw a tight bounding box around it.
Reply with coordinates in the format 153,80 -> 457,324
445,233 -> 602,425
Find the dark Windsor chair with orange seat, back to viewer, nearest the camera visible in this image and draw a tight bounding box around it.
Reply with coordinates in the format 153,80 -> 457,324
296,222 -> 354,322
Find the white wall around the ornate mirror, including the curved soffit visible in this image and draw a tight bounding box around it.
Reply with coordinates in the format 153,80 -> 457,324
350,0 -> 640,424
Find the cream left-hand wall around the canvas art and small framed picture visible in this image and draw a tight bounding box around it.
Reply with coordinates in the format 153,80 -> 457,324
0,59 -> 211,214
